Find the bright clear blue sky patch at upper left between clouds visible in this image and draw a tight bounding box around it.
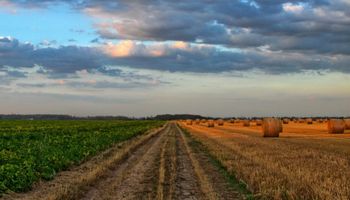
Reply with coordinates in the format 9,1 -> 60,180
0,4 -> 98,45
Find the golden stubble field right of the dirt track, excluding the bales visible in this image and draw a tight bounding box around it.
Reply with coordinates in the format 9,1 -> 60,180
182,122 -> 350,199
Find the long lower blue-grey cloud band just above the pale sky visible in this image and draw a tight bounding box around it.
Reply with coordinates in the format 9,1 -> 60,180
0,35 -> 350,74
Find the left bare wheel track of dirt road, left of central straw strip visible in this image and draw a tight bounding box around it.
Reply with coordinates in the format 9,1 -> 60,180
80,125 -> 170,200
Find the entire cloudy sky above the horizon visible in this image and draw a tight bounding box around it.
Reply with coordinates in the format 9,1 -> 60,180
0,0 -> 350,117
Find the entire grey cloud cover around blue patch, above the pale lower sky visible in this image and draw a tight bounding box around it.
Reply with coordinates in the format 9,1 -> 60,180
0,0 -> 350,77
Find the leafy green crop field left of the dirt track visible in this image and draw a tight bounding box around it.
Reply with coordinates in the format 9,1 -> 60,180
0,120 -> 164,196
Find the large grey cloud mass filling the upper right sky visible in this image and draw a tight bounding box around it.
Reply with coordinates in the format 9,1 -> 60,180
4,0 -> 350,55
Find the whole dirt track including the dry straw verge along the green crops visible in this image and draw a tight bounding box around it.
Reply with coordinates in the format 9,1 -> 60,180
7,122 -> 243,200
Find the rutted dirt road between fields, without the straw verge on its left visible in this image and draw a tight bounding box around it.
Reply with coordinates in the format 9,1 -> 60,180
80,123 -> 239,200
